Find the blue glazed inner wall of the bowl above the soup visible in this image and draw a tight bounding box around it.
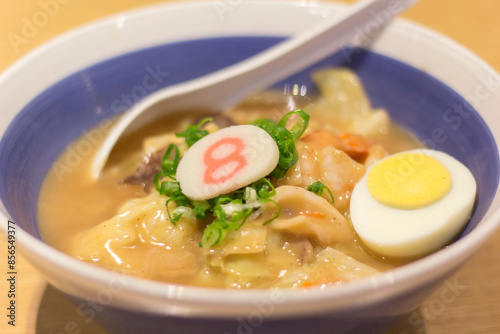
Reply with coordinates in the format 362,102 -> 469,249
0,36 -> 500,247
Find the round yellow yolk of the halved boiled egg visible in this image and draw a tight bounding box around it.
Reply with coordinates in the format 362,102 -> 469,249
367,152 -> 451,210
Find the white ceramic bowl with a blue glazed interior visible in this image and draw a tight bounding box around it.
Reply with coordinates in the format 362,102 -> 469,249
0,1 -> 500,334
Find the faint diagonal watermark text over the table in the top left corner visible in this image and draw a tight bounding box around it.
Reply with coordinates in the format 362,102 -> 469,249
7,0 -> 71,54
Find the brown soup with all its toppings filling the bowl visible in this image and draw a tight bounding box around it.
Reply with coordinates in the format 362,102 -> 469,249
38,69 -> 470,289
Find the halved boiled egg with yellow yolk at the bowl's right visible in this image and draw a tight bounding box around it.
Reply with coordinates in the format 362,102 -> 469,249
350,149 -> 476,257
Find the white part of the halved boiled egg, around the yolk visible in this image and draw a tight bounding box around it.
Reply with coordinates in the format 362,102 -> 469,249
350,149 -> 476,257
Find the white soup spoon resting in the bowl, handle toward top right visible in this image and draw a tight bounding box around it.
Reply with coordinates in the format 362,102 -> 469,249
91,0 -> 418,178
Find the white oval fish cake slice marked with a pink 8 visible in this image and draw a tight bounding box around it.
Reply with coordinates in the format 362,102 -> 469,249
176,125 -> 279,200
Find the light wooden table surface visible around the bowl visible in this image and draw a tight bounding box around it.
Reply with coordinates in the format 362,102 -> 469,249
0,0 -> 500,334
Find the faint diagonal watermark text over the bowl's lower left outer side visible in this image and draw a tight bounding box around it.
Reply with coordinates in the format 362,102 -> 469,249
49,273 -> 127,334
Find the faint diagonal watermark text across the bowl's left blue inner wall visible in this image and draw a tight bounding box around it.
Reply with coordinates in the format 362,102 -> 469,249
52,65 -> 169,182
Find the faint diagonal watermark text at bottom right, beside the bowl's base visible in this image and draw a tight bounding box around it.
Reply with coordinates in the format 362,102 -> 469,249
398,278 -> 467,334
